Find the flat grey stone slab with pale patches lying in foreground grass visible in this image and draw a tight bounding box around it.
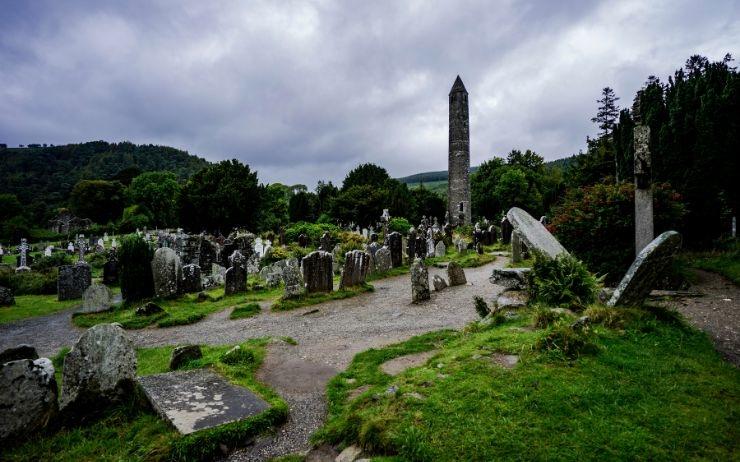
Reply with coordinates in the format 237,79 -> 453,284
138,369 -> 270,435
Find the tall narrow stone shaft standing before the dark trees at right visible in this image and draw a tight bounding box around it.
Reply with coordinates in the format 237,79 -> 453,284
632,91 -> 655,255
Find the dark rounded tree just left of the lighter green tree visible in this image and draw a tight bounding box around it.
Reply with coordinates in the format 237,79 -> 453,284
69,180 -> 124,224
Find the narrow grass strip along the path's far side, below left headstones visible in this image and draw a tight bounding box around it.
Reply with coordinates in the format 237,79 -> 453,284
72,288 -> 282,329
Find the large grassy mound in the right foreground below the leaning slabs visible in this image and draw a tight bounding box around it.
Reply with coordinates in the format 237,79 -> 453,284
313,307 -> 740,461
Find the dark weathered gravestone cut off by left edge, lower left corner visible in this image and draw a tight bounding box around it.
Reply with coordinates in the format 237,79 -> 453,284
0,358 -> 57,446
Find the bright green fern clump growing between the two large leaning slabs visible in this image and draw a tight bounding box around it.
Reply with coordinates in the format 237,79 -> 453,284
527,253 -> 599,309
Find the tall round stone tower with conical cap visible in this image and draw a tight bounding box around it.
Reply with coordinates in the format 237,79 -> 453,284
447,75 -> 471,225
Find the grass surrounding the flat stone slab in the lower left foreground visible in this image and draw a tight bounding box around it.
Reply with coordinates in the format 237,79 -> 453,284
2,339 -> 288,462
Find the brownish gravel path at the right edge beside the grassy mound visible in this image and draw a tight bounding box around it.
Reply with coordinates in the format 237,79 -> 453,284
664,270 -> 740,367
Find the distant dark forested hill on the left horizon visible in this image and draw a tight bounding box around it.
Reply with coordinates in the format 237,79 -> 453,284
0,141 -> 208,214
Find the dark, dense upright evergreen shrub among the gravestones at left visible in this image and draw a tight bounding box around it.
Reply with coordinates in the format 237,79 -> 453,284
118,234 -> 154,302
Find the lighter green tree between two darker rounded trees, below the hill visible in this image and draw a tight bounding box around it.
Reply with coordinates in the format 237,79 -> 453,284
128,172 -> 182,228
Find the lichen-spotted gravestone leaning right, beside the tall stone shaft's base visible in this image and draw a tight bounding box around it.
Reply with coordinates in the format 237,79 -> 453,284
607,231 -> 681,306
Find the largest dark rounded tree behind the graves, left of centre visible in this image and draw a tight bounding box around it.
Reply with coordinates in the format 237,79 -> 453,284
180,159 -> 262,233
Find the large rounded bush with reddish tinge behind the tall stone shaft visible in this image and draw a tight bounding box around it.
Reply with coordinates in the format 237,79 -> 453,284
549,183 -> 685,283
